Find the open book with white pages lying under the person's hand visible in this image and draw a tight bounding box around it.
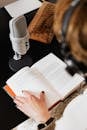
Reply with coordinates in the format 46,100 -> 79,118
4,53 -> 84,109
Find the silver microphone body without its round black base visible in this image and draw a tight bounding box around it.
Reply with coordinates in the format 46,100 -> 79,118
9,16 -> 30,60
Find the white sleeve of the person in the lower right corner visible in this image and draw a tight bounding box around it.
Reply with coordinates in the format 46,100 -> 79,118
55,94 -> 87,130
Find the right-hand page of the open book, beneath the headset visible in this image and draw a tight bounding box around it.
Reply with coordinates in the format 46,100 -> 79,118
32,53 -> 84,99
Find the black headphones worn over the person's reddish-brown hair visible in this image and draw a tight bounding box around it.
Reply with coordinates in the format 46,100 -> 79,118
60,0 -> 86,75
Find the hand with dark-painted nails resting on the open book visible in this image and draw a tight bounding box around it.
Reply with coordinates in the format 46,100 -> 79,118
14,91 -> 50,123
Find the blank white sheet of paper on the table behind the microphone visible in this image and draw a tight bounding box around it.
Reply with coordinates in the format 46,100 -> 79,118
5,0 -> 42,17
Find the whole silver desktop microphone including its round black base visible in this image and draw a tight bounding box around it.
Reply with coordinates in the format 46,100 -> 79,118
9,15 -> 31,71
